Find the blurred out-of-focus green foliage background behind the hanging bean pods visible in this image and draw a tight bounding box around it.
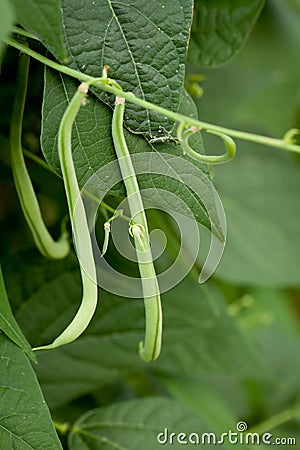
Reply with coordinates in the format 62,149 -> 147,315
0,0 -> 300,449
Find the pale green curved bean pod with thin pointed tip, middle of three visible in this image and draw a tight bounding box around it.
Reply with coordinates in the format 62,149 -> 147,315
34,83 -> 98,350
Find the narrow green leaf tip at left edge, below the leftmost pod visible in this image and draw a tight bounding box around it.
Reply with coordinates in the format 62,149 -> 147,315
0,267 -> 36,361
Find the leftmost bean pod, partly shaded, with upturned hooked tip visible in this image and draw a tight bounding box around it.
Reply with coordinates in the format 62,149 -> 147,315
10,54 -> 70,259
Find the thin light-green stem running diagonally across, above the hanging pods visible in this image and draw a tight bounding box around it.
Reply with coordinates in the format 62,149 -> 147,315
5,39 -> 300,158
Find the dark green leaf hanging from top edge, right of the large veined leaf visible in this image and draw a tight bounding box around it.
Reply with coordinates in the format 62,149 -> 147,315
189,0 -> 264,67
